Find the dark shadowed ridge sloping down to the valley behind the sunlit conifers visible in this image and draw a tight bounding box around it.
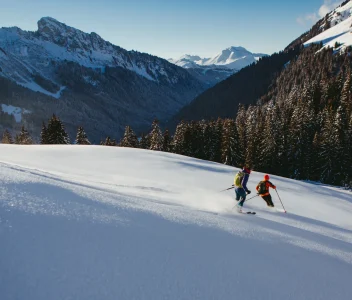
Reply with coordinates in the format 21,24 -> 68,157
169,46 -> 300,123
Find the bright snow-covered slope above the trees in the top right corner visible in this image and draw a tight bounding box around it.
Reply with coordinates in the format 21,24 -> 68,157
304,1 -> 352,50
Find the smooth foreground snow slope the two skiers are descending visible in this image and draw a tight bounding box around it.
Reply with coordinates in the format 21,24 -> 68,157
0,145 -> 352,300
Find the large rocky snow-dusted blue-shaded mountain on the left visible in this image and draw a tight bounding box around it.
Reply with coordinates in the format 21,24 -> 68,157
0,17 -> 206,141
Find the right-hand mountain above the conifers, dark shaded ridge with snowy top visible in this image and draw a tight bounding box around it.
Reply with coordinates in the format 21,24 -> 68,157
170,1 -> 352,127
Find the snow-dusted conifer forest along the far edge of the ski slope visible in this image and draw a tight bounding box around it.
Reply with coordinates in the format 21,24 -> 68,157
3,45 -> 352,187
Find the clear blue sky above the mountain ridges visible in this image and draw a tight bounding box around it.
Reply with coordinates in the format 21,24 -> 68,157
0,0 -> 342,58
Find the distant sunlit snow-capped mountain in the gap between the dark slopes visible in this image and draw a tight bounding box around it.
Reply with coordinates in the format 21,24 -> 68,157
169,47 -> 267,86
